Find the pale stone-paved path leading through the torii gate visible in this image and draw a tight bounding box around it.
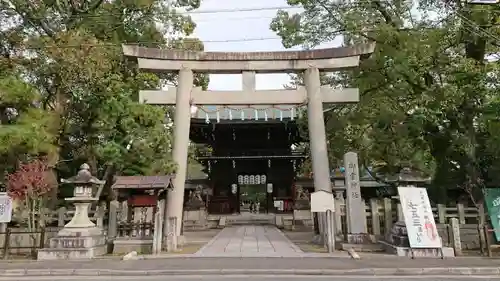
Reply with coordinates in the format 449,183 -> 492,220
195,225 -> 303,257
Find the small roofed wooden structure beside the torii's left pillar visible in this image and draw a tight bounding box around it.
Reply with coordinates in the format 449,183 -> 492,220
112,175 -> 173,253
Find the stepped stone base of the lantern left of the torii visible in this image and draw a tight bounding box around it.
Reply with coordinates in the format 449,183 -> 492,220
38,227 -> 107,260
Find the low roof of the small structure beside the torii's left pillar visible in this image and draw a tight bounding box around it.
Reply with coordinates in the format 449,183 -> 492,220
112,175 -> 174,189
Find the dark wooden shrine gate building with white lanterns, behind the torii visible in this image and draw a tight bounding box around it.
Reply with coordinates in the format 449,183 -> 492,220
185,106 -> 306,214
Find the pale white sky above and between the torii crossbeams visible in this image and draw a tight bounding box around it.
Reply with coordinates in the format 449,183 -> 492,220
191,0 -> 342,91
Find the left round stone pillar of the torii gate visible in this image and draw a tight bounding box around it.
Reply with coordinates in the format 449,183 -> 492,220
165,68 -> 193,236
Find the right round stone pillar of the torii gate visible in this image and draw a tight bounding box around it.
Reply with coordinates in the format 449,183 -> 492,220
304,68 -> 332,192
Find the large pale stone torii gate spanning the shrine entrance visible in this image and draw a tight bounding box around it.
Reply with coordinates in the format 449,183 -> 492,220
122,44 -> 375,235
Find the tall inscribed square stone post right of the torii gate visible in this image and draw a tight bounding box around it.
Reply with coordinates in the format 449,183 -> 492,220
344,152 -> 367,234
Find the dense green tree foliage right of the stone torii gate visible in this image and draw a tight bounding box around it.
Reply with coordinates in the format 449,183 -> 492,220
271,0 -> 500,200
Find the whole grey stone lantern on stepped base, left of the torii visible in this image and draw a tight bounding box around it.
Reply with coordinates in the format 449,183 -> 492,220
38,164 -> 106,260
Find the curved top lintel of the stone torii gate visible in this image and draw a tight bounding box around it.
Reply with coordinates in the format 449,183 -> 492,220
122,43 -> 375,61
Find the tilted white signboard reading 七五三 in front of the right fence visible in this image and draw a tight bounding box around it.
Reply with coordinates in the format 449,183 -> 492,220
398,187 -> 442,248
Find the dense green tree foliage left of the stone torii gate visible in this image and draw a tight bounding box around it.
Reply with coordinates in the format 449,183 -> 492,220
0,0 -> 208,203
